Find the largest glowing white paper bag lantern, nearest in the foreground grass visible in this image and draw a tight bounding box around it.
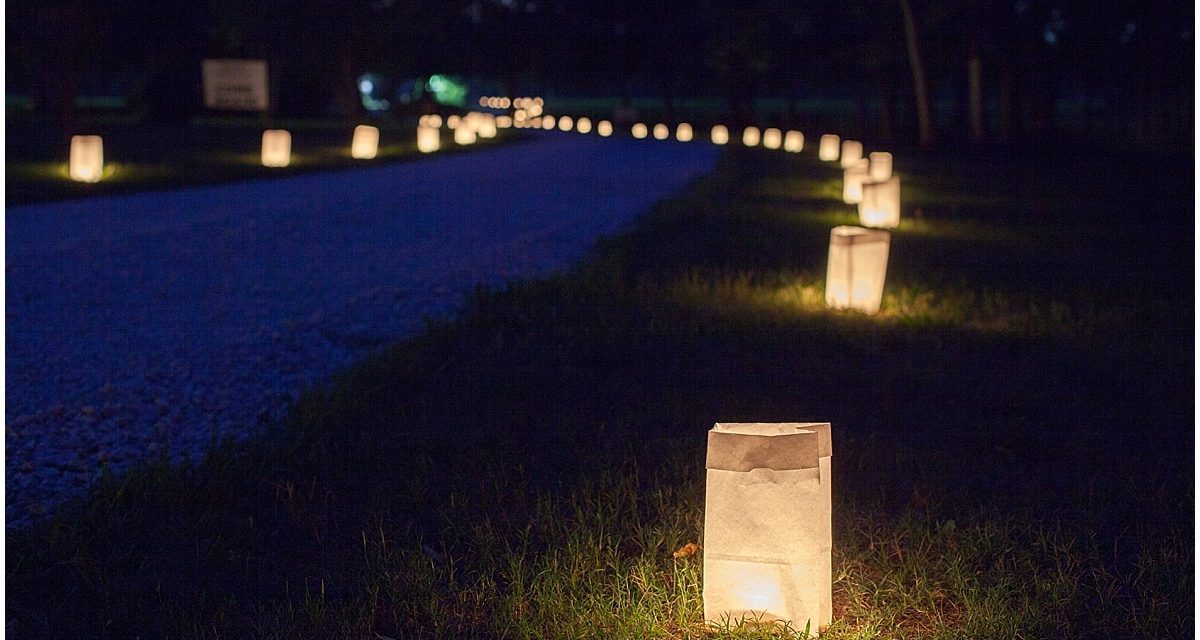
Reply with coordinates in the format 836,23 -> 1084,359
703,423 -> 833,633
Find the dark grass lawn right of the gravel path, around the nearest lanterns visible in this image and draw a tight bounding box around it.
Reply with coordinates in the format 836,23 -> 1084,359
6,142 -> 1194,639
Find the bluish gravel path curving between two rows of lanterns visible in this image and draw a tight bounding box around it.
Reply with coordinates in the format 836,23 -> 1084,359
5,132 -> 716,526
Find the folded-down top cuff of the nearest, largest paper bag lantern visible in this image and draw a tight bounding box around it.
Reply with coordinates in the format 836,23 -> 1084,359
704,423 -> 833,471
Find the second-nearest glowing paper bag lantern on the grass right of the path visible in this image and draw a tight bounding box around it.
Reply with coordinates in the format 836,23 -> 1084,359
826,225 -> 892,315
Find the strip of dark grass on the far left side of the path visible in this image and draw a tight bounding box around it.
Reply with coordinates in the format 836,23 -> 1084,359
5,115 -> 520,205
